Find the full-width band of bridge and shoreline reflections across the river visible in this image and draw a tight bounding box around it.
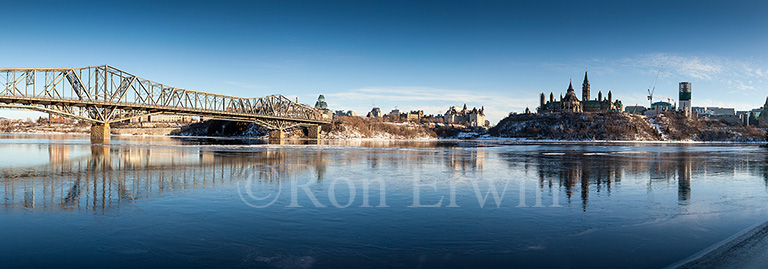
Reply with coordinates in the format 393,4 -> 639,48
0,138 -> 768,211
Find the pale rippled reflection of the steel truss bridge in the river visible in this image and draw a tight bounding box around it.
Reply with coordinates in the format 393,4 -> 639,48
0,144 -> 325,211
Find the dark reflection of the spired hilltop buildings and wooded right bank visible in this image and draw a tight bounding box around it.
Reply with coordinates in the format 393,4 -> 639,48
508,147 -> 768,211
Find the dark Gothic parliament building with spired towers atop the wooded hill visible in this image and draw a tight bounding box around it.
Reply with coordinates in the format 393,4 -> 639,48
537,72 -> 623,113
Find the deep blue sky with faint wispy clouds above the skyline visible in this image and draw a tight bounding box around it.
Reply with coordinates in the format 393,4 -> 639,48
0,0 -> 768,124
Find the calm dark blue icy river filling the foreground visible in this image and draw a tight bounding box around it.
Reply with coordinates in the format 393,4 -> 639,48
0,135 -> 768,268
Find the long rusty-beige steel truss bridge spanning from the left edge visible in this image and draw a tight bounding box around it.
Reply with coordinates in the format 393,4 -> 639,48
0,65 -> 329,137
